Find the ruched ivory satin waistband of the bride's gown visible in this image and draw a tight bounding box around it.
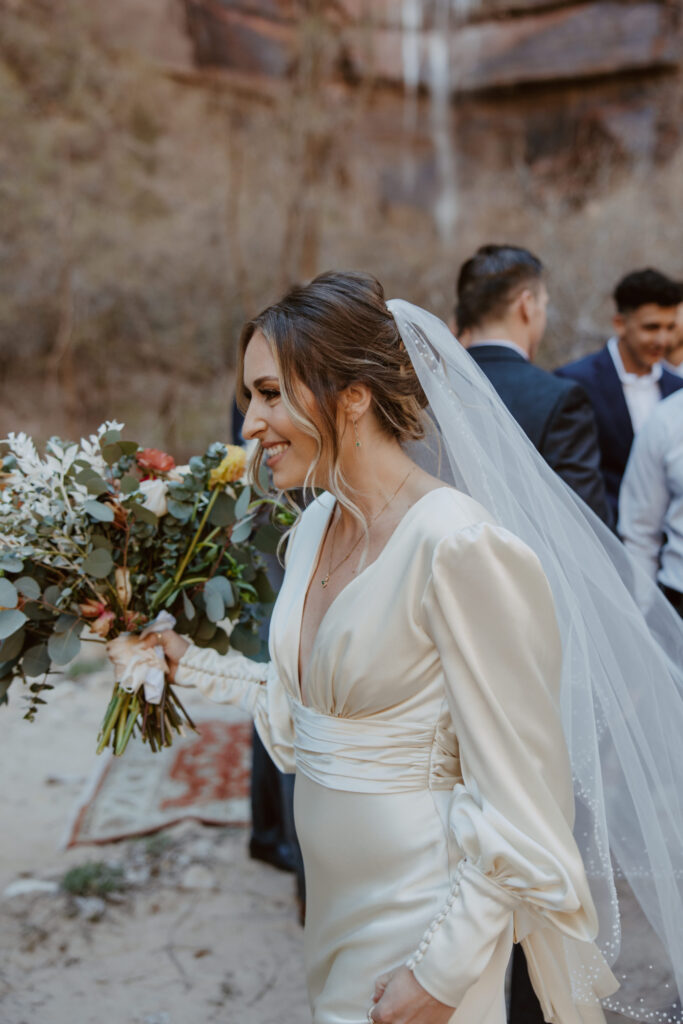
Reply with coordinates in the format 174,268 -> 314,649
293,702 -> 462,793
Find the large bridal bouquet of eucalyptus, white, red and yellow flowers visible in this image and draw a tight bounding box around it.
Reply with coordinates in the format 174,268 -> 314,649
0,422 -> 287,755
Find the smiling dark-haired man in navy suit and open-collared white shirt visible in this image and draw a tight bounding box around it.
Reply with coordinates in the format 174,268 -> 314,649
555,269 -> 683,518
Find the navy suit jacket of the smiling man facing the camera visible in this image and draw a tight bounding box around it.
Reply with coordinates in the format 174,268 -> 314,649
555,346 -> 683,521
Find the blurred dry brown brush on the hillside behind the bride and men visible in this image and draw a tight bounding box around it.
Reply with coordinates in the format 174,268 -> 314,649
0,0 -> 683,459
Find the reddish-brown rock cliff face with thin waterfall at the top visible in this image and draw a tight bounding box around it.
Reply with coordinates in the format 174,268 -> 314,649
184,0 -> 683,216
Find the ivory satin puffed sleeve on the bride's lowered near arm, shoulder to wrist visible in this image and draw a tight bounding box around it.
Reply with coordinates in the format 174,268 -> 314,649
409,524 -> 597,1019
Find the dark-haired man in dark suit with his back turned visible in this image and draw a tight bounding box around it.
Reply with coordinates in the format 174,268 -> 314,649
455,245 -> 611,524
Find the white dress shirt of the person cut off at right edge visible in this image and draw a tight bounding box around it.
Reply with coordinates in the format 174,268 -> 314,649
618,391 -> 683,593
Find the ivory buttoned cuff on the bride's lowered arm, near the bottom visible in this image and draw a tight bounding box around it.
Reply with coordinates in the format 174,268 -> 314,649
407,860 -> 518,1007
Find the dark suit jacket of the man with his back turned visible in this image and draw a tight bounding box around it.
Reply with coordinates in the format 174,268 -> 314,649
469,344 -> 612,526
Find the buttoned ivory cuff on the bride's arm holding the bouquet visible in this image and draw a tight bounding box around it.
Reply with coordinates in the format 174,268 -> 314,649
175,644 -> 267,718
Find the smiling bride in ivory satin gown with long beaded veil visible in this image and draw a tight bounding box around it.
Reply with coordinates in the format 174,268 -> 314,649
146,273 -> 680,1024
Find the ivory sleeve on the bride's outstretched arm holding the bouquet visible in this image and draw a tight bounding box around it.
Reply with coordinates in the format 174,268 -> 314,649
175,644 -> 295,772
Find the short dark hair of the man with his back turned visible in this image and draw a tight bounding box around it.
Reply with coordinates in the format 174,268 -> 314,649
456,245 -> 543,331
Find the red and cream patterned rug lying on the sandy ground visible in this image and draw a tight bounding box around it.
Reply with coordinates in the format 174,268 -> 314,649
63,709 -> 252,847
